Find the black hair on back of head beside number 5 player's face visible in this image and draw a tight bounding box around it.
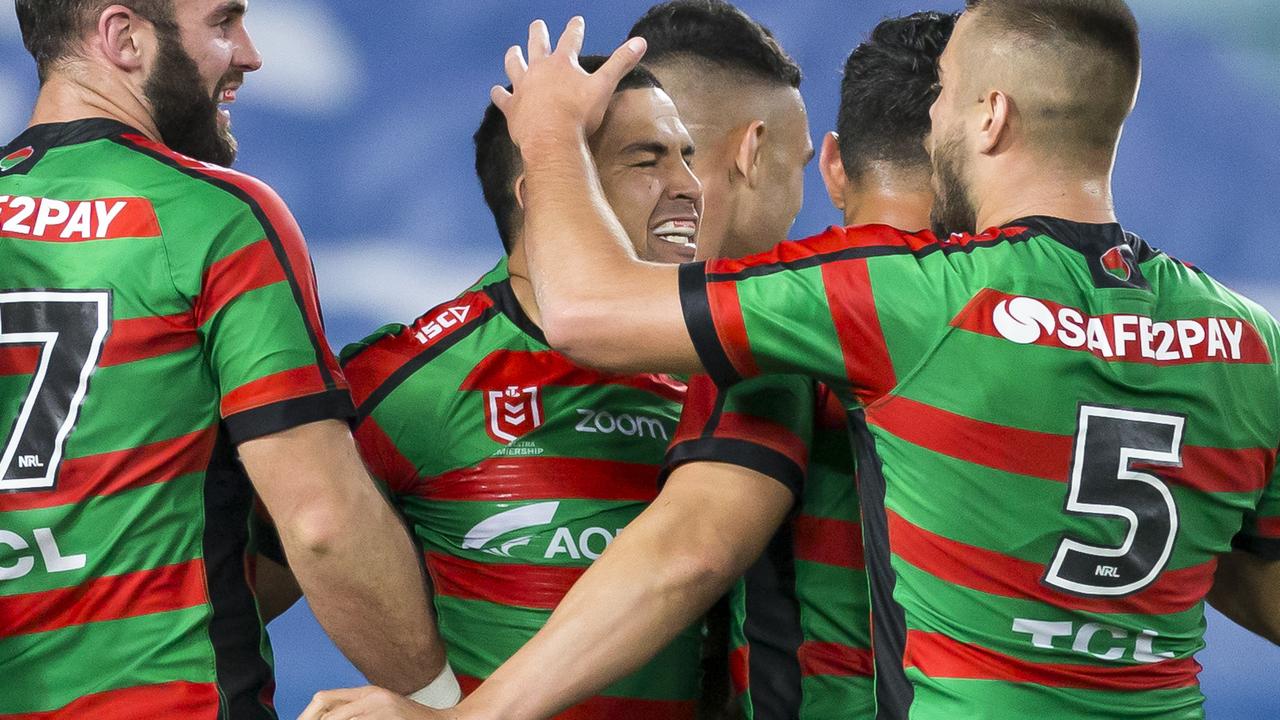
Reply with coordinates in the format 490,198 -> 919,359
836,12 -> 956,178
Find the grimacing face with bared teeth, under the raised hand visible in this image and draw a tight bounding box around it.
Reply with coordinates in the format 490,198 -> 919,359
590,87 -> 703,263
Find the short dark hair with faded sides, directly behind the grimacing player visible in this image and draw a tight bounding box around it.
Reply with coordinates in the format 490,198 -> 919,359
627,0 -> 804,88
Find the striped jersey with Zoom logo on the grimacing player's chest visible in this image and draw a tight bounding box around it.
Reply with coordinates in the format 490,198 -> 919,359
343,260 -> 701,720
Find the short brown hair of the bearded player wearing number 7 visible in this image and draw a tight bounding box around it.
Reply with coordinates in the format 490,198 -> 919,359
14,0 -> 178,83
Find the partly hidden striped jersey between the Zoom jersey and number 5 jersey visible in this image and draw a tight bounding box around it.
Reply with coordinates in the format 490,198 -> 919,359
667,375 -> 876,720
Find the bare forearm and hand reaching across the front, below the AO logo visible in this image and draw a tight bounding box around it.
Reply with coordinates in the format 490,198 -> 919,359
301,462 -> 794,720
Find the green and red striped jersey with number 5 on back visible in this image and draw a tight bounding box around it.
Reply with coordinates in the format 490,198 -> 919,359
681,218 -> 1280,719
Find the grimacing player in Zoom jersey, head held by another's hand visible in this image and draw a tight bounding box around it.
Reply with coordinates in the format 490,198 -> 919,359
343,58 -> 701,720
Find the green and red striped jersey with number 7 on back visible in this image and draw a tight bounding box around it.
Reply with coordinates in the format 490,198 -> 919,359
0,119 -> 353,720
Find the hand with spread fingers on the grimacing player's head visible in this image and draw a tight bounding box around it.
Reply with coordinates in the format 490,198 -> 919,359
490,17 -> 645,149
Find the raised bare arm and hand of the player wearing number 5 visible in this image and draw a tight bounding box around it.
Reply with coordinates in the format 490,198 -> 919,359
494,18 -> 701,374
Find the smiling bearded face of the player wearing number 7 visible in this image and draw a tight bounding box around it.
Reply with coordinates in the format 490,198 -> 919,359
143,0 -> 262,165
